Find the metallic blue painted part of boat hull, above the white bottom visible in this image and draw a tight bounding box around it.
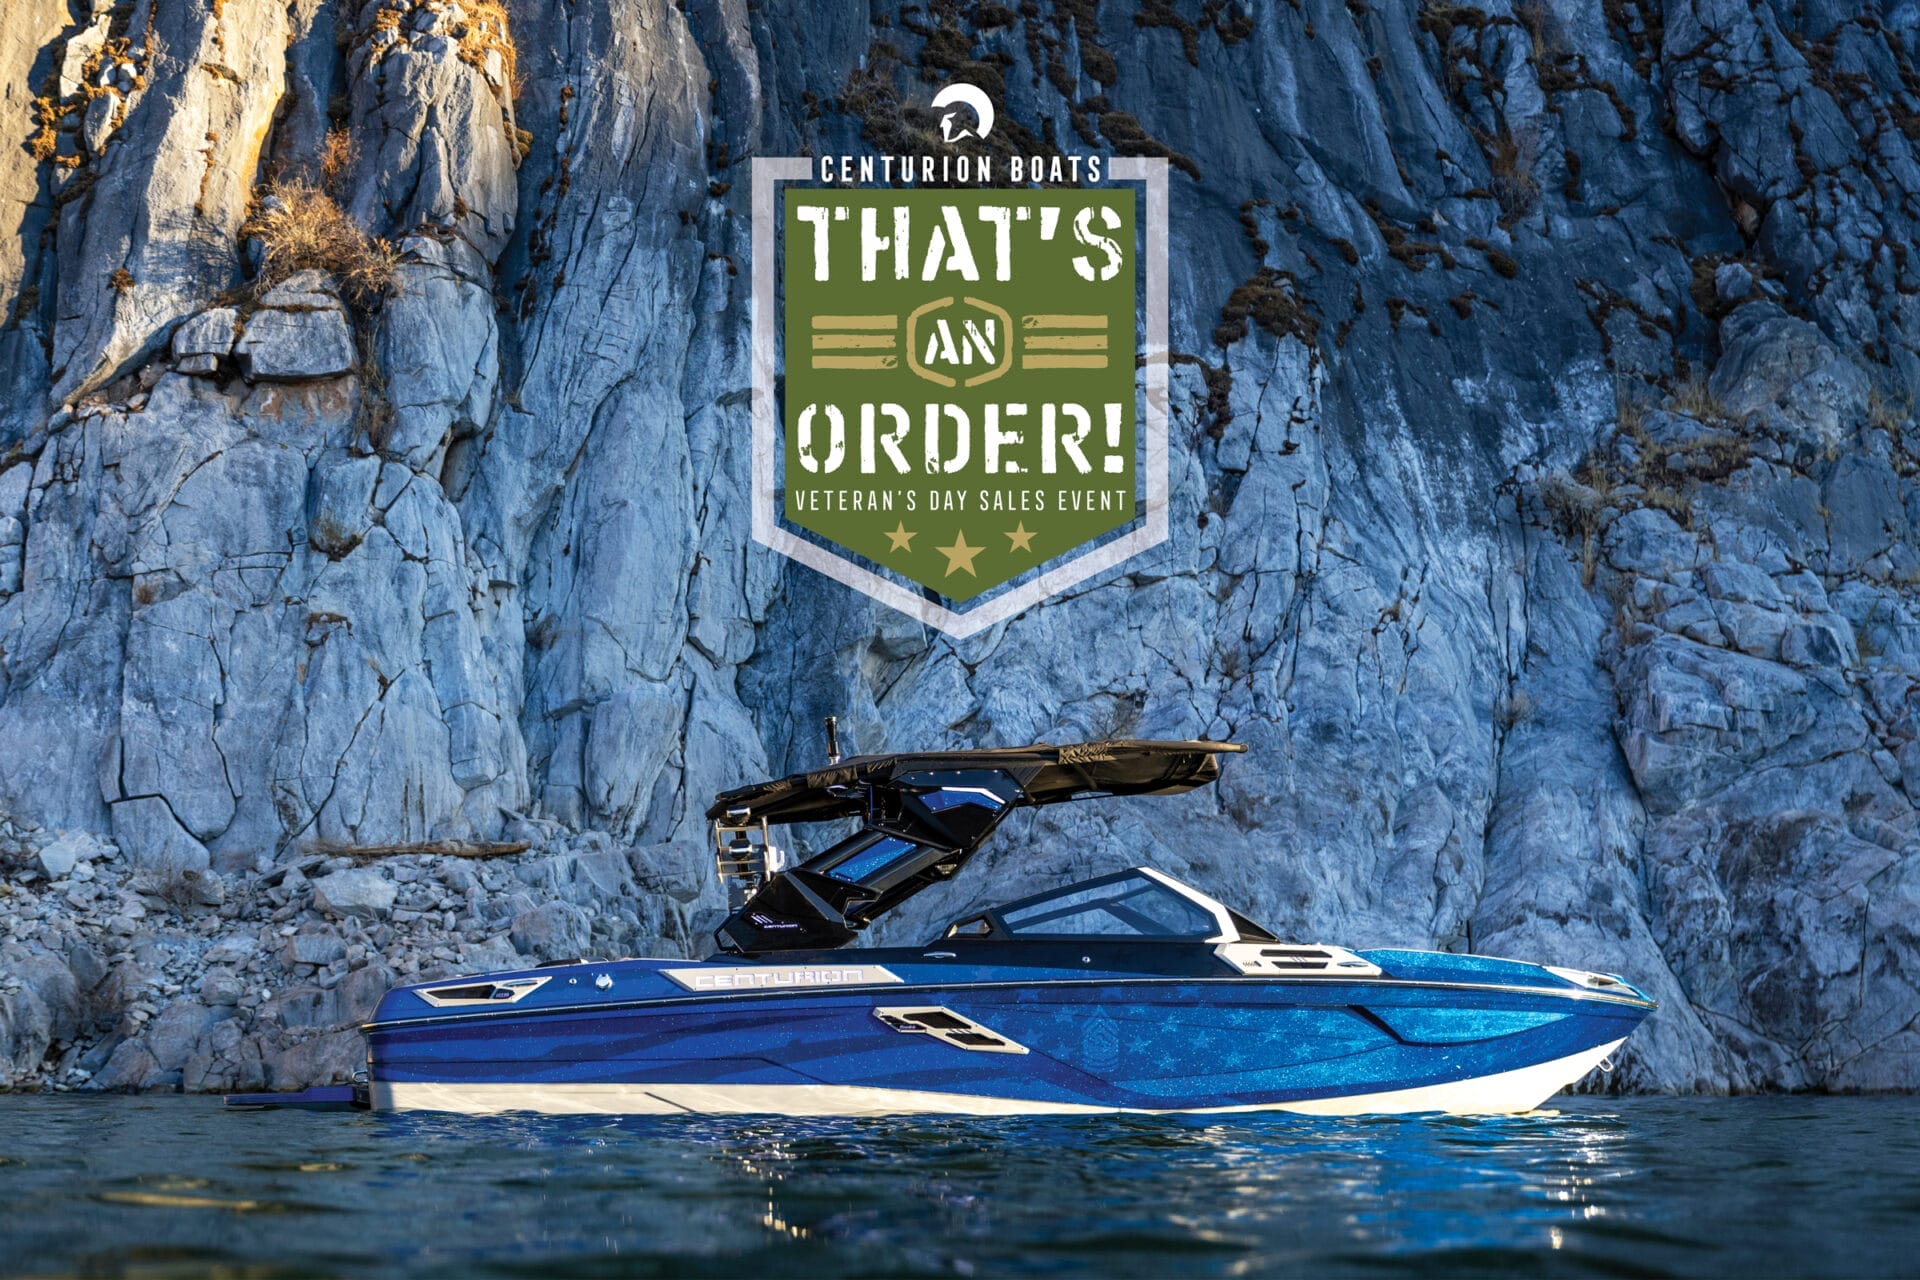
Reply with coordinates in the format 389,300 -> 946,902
369,948 -> 1649,1109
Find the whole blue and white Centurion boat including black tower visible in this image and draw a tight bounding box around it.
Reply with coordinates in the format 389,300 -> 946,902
345,741 -> 1653,1115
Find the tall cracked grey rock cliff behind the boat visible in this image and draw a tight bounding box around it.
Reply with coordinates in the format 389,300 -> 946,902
0,0 -> 1920,1090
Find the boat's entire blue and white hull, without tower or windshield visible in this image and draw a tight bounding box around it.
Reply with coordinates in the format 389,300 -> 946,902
369,961 -> 1651,1115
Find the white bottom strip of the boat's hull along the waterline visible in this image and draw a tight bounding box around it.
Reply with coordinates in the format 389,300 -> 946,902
372,1036 -> 1626,1115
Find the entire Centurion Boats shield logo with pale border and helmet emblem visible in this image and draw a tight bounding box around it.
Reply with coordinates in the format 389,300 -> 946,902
753,110 -> 1167,635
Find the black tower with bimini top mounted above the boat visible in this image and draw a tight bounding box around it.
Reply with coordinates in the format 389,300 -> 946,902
707,741 -> 1246,954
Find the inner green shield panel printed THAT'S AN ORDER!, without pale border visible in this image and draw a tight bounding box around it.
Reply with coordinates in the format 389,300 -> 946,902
783,188 -> 1137,601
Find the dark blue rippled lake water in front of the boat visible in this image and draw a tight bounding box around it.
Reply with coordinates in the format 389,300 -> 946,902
0,1098 -> 1920,1276
